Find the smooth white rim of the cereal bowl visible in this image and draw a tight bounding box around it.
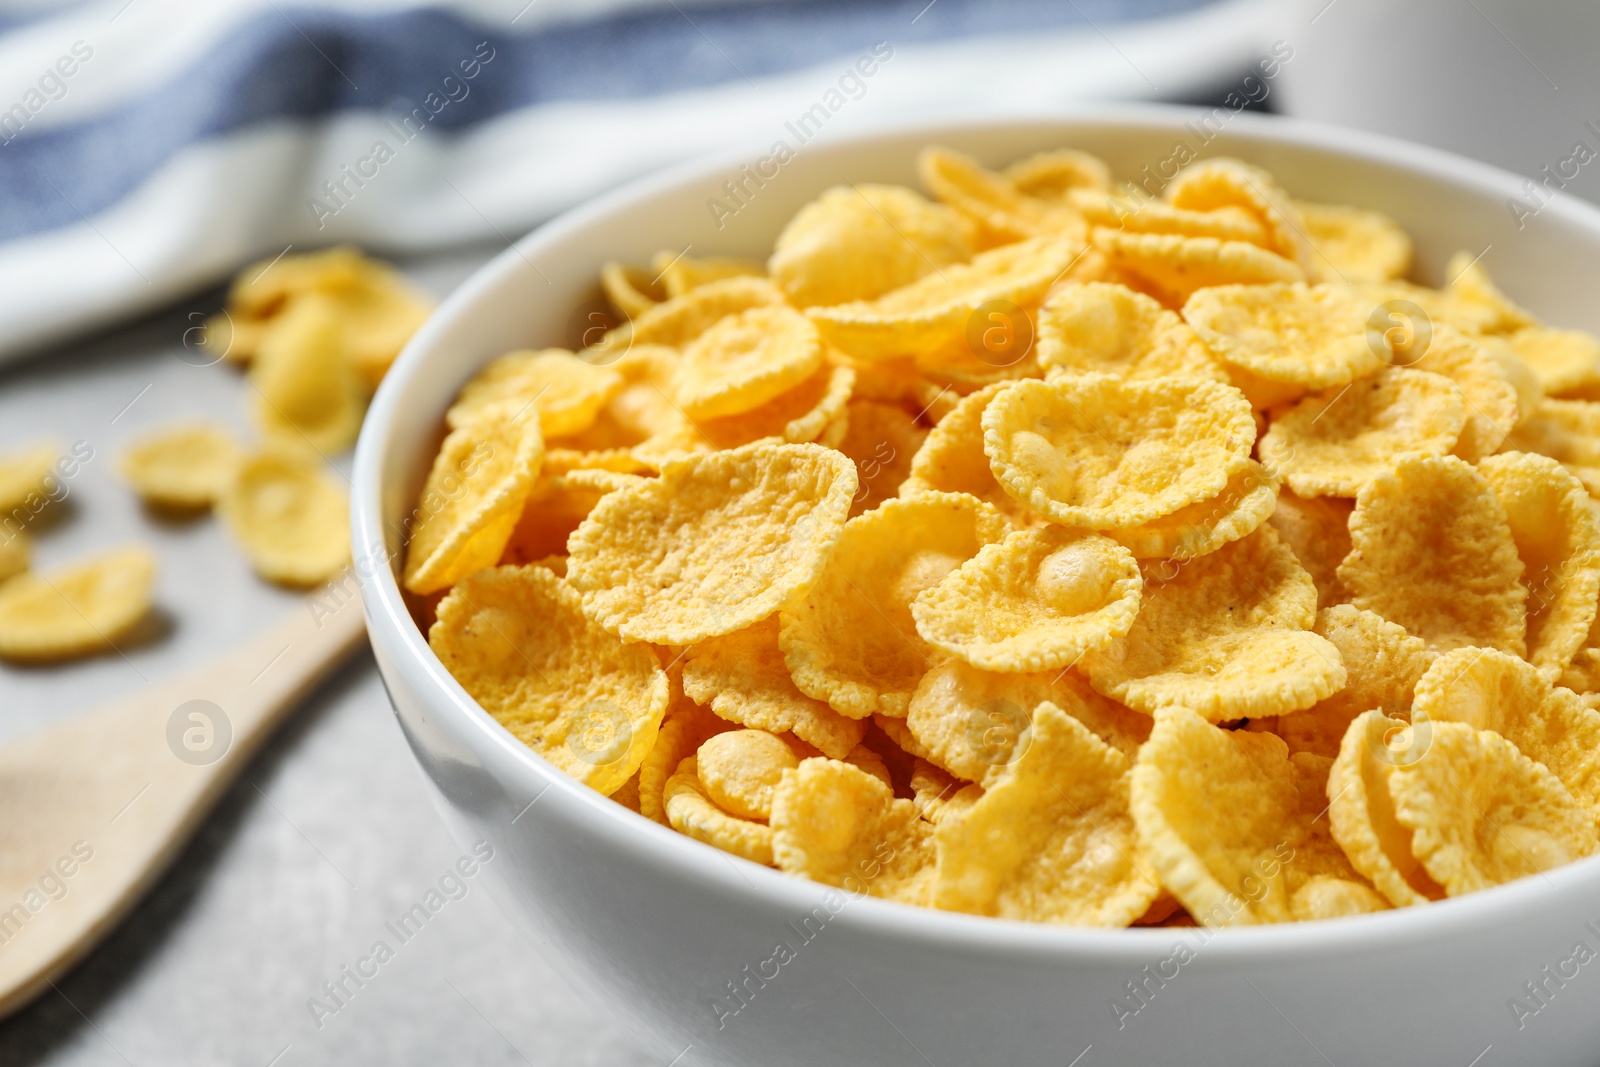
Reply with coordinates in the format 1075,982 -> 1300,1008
350,104 -> 1600,968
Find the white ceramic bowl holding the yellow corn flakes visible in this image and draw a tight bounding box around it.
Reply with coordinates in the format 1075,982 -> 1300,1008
354,109 -> 1600,1067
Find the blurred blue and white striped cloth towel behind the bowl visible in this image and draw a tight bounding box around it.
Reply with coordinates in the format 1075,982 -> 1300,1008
0,0 -> 1270,358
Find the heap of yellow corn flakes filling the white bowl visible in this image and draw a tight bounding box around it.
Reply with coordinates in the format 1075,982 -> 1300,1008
403,149 -> 1600,926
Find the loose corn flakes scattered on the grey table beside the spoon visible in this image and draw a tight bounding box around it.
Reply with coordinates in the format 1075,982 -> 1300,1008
0,248 -> 432,661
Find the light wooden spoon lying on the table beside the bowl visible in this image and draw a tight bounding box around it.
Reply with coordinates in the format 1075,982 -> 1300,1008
0,593 -> 365,1017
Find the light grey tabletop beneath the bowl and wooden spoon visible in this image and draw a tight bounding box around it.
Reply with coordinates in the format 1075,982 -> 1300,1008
0,248 -> 650,1067
